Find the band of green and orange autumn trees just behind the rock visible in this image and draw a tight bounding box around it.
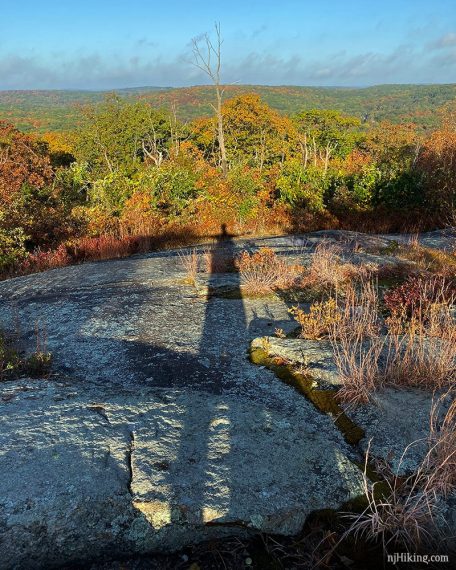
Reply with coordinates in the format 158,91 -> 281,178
0,93 -> 456,274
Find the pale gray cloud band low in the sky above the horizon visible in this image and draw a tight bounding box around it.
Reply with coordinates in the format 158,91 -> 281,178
0,42 -> 456,89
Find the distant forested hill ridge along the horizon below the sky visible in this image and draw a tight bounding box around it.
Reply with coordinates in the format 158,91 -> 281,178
0,84 -> 456,132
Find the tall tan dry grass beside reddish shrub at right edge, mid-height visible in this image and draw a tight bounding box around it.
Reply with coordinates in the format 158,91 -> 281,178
330,272 -> 456,405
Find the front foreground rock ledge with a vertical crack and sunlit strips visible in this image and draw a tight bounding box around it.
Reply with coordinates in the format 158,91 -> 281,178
0,374 -> 361,569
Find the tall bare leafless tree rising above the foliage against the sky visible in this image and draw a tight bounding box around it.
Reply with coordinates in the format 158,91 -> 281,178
192,23 -> 228,176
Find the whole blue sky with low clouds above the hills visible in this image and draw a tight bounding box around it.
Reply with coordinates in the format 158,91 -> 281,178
0,0 -> 456,89
